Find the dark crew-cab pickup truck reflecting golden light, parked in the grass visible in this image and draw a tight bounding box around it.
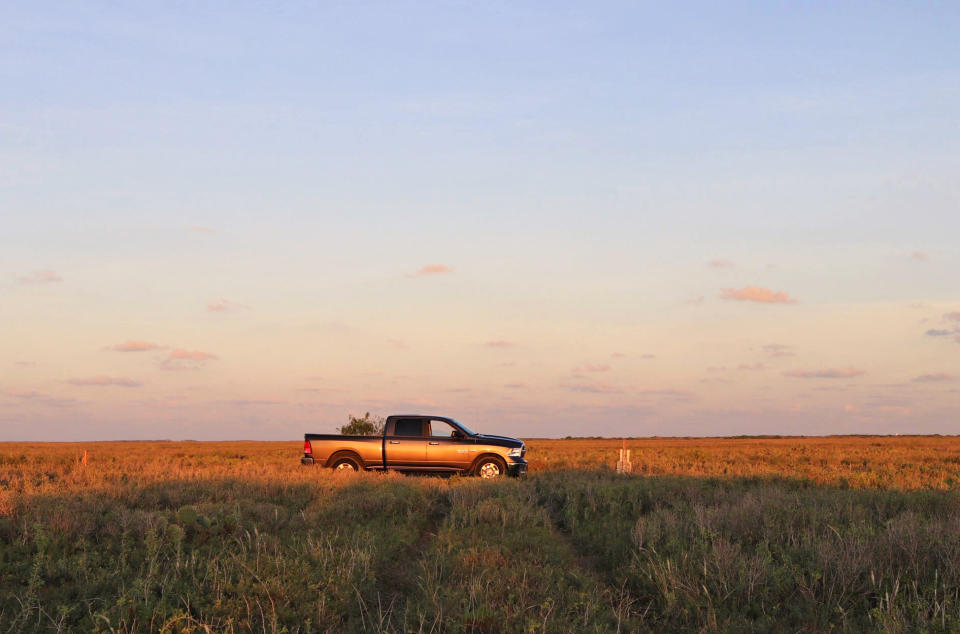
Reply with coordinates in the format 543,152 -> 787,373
300,415 -> 527,478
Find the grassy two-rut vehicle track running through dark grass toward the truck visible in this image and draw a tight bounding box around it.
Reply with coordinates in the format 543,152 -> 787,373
407,480 -> 636,632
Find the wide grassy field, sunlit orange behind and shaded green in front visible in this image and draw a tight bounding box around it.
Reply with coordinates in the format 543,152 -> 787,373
0,437 -> 960,632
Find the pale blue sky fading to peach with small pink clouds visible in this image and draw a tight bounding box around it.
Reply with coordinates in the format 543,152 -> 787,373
0,0 -> 960,440
